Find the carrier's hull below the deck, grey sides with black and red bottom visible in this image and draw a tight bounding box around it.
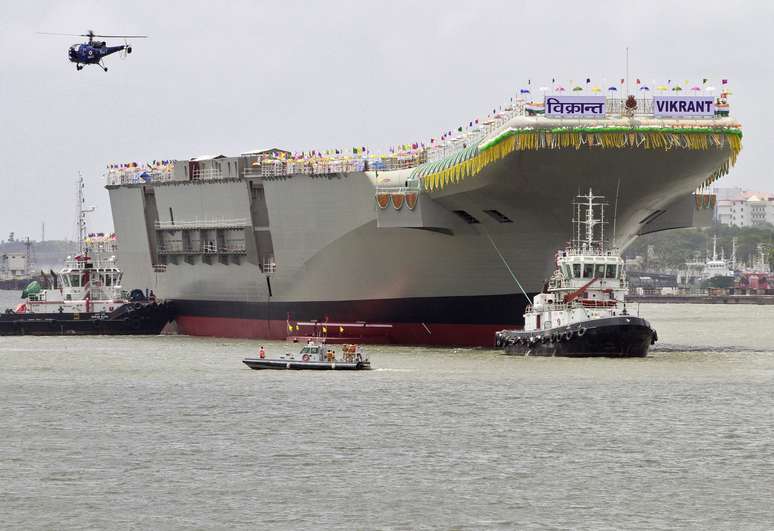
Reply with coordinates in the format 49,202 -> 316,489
108,120 -> 730,346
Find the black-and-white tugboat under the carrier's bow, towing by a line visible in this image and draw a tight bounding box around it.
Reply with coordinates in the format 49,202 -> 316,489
495,189 -> 658,357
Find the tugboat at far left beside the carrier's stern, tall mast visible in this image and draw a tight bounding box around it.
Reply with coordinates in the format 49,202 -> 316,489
0,178 -> 173,336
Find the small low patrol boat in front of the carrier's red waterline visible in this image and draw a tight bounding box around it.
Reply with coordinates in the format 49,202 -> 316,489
242,341 -> 371,371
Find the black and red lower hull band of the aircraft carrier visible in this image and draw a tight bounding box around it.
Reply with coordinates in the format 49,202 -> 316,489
173,294 -> 526,348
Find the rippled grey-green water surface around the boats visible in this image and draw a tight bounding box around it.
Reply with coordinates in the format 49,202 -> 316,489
0,288 -> 774,529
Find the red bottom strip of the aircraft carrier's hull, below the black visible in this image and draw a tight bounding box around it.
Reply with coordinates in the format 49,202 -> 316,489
176,315 -> 515,348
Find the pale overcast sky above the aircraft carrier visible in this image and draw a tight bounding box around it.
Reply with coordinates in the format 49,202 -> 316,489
0,0 -> 774,239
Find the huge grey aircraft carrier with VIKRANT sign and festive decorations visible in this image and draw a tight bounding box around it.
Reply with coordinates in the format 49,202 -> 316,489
107,92 -> 742,346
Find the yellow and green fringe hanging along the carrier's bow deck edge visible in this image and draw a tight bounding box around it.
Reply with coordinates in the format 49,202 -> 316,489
412,127 -> 742,191
